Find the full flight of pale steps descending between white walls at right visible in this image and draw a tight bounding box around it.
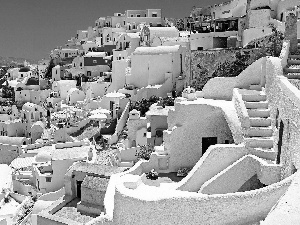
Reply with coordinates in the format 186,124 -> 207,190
242,88 -> 273,158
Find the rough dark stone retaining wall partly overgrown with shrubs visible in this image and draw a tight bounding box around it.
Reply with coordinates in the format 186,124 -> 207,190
189,31 -> 283,90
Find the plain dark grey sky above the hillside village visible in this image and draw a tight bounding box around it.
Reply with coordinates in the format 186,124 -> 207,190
0,0 -> 225,59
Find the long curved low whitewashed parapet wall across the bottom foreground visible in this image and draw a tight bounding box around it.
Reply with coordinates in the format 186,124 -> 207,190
111,175 -> 291,225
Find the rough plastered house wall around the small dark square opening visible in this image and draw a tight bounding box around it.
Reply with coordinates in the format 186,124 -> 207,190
164,104 -> 232,171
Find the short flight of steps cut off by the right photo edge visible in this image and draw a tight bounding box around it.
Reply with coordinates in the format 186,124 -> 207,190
283,39 -> 300,79
